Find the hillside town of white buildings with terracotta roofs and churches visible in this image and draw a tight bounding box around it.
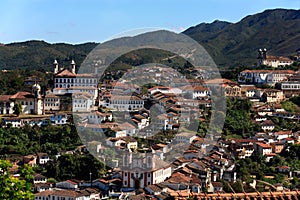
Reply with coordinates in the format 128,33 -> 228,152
0,49 -> 300,200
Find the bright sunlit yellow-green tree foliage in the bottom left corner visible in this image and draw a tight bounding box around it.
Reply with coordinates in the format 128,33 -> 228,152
0,160 -> 34,200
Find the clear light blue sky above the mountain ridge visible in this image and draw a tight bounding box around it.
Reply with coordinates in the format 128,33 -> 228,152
0,0 -> 300,44
